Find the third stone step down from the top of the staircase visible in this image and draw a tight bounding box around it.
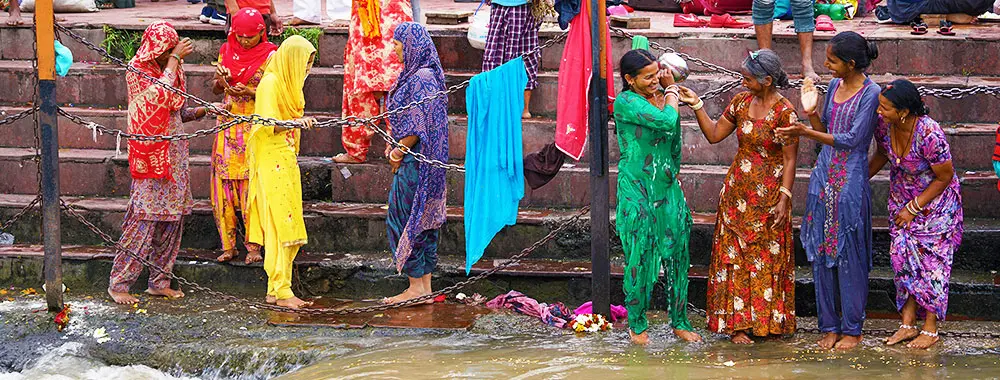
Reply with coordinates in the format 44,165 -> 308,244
0,106 -> 997,170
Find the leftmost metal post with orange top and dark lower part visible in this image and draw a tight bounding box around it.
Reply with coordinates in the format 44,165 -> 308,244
35,0 -> 63,311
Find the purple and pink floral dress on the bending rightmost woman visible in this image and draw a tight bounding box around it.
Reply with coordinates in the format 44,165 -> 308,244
875,116 -> 963,320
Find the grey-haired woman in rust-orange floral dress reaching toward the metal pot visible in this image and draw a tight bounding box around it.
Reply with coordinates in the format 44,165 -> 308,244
681,49 -> 798,344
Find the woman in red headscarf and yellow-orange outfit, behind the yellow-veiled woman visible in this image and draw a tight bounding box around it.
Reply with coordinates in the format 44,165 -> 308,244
212,8 -> 278,264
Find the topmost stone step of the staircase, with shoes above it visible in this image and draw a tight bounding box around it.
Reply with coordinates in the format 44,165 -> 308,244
13,17 -> 1000,76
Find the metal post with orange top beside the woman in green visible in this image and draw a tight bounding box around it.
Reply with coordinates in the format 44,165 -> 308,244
588,0 -> 611,316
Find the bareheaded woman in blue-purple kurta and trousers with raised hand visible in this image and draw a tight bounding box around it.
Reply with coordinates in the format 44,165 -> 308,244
778,32 -> 880,349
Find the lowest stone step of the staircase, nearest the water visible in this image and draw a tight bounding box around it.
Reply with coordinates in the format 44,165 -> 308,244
0,245 -> 1000,320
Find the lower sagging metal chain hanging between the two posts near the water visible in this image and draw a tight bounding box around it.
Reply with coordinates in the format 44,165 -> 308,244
59,199 -> 590,316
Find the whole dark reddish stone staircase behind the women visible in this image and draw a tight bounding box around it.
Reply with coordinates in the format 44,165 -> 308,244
0,23 -> 1000,319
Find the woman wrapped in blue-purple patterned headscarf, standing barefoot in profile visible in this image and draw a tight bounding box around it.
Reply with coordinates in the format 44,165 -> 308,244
383,22 -> 448,303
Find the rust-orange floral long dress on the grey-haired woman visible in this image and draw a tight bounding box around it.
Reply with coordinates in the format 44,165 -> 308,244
707,92 -> 798,336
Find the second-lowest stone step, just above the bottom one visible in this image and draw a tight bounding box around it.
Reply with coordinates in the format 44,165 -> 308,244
0,194 -> 1000,271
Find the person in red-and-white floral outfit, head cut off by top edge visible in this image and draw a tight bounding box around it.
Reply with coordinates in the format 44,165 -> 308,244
333,0 -> 413,163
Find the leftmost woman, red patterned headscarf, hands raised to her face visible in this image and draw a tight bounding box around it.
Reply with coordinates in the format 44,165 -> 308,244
108,21 -> 192,304
